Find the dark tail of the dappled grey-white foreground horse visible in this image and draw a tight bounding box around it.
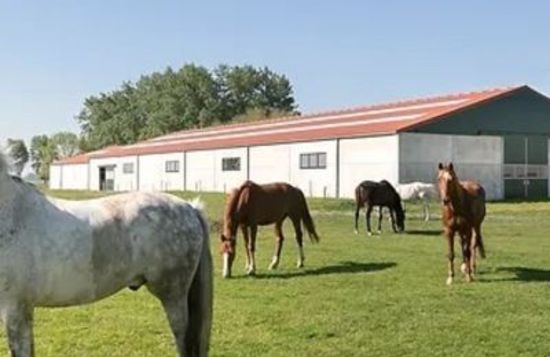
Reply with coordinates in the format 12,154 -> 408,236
185,200 -> 213,357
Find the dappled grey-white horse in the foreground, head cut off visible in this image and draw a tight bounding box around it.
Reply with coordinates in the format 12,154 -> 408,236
0,153 -> 212,357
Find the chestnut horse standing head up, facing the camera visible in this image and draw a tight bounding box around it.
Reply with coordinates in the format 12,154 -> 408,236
437,163 -> 485,285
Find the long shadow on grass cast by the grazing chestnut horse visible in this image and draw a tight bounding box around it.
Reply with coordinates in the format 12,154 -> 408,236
248,261 -> 397,279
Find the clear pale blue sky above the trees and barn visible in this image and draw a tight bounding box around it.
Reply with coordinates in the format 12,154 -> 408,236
0,0 -> 550,146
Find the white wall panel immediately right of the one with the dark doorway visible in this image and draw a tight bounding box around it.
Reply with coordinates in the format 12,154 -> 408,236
139,152 -> 185,191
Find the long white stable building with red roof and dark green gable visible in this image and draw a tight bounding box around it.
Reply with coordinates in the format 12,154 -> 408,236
50,86 -> 550,199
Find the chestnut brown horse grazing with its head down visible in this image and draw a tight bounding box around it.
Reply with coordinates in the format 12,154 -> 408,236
221,181 -> 319,277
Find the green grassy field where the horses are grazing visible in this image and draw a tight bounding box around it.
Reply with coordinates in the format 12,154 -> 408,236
0,188 -> 550,356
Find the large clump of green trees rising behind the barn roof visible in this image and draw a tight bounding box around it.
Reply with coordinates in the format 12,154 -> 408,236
77,64 -> 296,151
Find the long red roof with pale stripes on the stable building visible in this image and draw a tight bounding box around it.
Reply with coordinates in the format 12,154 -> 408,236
55,86 -> 525,164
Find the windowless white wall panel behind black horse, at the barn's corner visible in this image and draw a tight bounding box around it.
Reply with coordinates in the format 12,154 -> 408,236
340,135 -> 399,198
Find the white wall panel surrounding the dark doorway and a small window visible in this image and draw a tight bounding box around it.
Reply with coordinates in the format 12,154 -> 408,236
89,156 -> 138,191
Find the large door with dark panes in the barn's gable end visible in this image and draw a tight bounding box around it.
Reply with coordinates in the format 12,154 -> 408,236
503,135 -> 548,199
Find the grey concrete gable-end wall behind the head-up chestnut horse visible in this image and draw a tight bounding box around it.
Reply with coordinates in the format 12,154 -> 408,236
399,133 -> 504,199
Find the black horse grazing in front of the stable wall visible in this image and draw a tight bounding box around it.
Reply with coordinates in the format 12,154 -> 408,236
355,180 -> 405,235
